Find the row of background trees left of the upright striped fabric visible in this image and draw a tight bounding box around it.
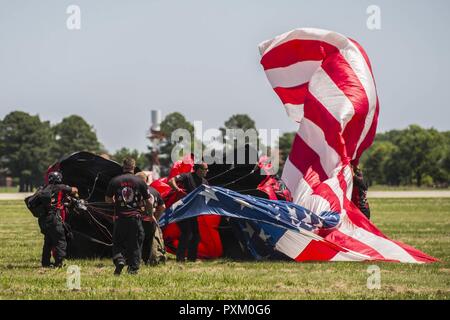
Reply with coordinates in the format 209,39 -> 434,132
0,111 -> 256,192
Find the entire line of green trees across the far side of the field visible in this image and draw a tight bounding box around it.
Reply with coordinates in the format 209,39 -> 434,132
0,111 -> 450,191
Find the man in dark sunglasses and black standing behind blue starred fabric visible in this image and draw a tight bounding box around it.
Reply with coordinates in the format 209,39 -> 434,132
169,162 -> 209,262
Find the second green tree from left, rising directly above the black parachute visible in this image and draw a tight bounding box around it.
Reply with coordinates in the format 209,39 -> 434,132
53,115 -> 104,158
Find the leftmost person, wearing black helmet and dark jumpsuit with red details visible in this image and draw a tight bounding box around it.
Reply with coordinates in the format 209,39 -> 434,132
38,171 -> 78,268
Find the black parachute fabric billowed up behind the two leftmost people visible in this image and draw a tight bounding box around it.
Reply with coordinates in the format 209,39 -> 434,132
47,152 -> 140,258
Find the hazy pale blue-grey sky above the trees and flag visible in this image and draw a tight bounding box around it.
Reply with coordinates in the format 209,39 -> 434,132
0,0 -> 450,152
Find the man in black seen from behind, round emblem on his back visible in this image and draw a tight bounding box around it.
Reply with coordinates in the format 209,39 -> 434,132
106,158 -> 155,275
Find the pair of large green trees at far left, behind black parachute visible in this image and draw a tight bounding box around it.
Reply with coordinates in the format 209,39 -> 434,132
0,111 -> 104,192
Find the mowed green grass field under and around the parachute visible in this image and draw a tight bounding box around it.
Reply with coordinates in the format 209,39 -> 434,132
0,199 -> 450,299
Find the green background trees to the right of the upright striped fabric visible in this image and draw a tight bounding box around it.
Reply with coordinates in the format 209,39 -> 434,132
279,125 -> 450,187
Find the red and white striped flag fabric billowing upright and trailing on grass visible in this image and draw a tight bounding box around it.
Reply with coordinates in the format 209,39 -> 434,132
259,28 -> 436,263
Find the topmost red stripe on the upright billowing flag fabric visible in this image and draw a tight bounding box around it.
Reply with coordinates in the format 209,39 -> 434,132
261,39 -> 338,70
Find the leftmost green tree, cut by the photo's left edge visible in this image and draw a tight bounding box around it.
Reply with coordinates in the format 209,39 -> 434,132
0,111 -> 54,192
